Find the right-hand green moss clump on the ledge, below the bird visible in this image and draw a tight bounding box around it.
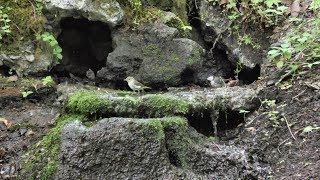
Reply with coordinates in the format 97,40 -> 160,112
140,94 -> 189,117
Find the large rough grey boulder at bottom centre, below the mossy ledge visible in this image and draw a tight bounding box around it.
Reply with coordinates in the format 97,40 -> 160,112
54,117 -> 268,179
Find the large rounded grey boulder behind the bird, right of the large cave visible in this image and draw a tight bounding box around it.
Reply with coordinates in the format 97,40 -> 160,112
97,24 -> 204,87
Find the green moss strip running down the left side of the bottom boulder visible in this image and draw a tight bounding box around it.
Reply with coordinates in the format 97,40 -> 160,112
21,115 -> 84,180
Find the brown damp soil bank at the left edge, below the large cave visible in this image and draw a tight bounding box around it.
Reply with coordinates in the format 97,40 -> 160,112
0,86 -> 59,179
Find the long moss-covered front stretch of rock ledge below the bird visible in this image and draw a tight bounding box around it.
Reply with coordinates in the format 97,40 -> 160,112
66,91 -> 191,117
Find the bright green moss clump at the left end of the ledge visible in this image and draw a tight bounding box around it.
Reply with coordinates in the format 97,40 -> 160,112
67,91 -> 111,115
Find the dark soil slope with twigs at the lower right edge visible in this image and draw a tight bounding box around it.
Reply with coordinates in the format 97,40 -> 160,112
229,67 -> 320,179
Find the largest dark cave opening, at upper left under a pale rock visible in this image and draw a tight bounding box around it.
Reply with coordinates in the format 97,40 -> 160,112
53,17 -> 113,77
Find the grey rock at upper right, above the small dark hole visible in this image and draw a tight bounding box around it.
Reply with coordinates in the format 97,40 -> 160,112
199,0 -> 270,69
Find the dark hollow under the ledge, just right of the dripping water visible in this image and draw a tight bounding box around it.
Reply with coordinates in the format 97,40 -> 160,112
216,109 -> 244,137
